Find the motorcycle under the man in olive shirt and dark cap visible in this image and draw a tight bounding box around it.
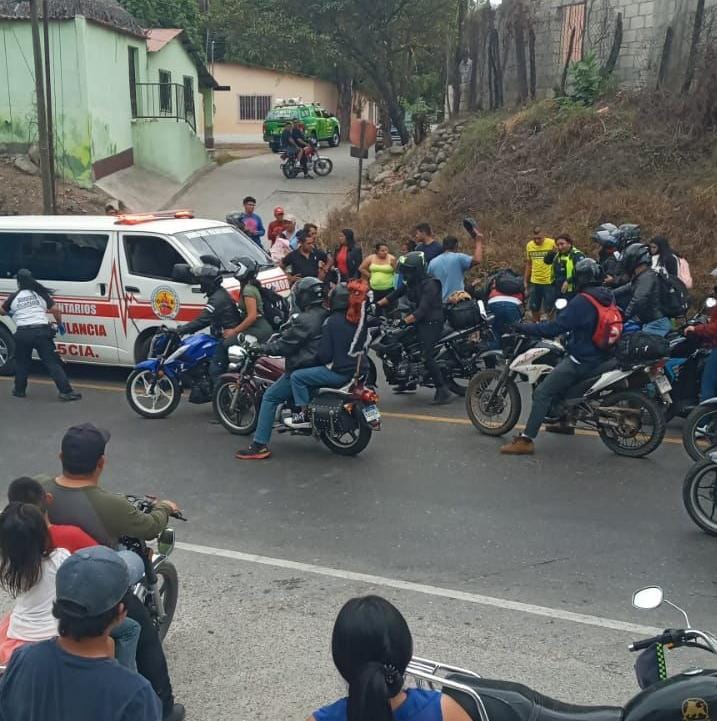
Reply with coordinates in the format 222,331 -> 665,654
119,495 -> 187,641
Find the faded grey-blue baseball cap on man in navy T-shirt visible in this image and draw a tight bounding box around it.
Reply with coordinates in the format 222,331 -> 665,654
55,546 -> 144,618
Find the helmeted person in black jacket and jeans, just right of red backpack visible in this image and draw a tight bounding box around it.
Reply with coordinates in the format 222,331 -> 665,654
615,243 -> 672,336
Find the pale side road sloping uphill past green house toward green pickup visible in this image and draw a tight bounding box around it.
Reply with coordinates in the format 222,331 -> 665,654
177,146 -> 358,233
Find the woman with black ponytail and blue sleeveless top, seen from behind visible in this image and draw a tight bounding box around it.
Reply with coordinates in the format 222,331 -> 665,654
308,596 -> 470,721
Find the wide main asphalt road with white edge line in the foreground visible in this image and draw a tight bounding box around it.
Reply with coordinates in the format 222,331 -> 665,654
0,368 -> 717,721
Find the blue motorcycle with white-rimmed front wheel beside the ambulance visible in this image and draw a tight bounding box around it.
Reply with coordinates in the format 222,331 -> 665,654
125,327 -> 219,418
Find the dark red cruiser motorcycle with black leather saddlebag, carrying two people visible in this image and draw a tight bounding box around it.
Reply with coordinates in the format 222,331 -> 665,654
214,334 -> 381,456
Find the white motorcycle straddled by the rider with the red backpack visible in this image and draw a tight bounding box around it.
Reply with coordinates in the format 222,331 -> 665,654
466,333 -> 669,458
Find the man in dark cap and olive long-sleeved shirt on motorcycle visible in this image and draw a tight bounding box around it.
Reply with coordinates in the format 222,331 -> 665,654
36,423 -> 184,721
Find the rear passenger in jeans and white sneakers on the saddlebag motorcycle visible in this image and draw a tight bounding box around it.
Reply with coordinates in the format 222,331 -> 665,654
286,284 -> 368,430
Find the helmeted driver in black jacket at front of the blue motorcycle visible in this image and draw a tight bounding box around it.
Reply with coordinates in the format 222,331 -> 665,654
177,256 -> 242,385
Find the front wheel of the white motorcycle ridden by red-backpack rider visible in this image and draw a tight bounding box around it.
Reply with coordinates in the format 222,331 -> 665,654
466,368 -> 521,436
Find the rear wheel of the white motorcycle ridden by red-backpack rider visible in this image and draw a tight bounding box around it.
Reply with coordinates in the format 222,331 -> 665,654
598,391 -> 665,458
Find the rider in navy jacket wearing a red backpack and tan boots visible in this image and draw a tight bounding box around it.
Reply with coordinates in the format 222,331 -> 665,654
500,258 -> 615,456
